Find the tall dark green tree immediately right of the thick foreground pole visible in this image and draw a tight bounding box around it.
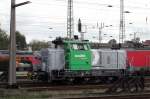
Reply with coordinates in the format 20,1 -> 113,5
16,31 -> 27,50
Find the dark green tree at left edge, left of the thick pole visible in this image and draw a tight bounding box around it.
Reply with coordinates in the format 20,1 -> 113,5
0,29 -> 9,50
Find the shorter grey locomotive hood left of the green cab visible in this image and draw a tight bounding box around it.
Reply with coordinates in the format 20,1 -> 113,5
42,48 -> 65,72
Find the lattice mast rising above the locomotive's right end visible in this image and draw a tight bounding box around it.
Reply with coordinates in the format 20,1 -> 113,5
119,0 -> 125,43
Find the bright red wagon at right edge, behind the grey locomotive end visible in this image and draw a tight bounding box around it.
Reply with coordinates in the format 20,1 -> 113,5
127,50 -> 150,67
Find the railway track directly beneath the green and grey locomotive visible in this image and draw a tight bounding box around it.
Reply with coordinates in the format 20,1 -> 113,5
0,78 -> 150,91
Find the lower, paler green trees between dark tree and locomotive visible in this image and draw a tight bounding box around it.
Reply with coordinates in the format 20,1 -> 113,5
29,40 -> 48,51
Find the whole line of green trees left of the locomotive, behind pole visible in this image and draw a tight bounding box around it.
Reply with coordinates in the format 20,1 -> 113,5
0,28 -> 48,51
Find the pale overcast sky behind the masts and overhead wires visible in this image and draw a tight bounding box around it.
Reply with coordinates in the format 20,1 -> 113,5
0,0 -> 150,42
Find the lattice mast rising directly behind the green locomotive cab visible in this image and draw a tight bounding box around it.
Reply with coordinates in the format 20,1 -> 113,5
67,0 -> 74,39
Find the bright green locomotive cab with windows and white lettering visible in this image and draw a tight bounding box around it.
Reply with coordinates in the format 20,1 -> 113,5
64,41 -> 91,70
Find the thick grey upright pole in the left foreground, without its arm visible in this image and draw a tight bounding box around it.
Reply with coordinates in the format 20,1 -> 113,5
8,0 -> 16,86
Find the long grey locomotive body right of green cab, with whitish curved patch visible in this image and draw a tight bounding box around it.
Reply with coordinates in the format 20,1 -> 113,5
92,49 -> 126,70
